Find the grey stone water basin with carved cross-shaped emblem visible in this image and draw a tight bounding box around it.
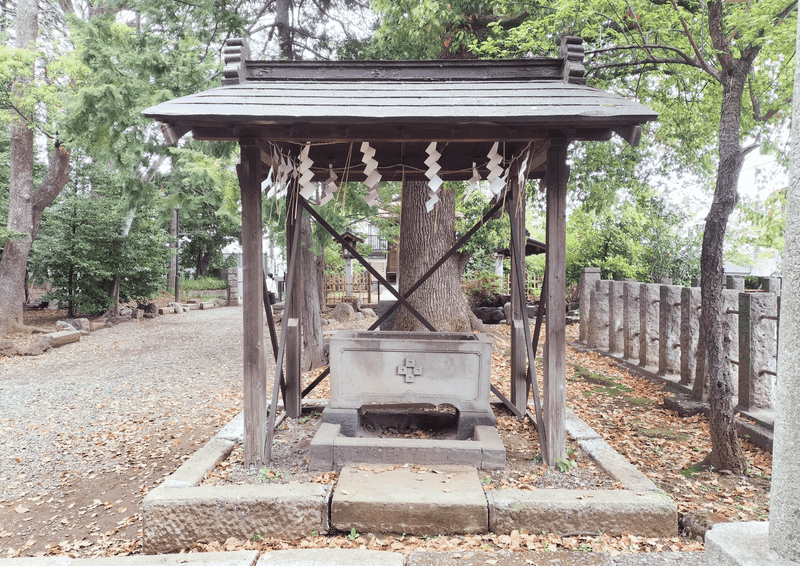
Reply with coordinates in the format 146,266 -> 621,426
322,331 -> 494,440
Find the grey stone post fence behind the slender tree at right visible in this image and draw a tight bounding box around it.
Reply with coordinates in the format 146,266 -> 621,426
580,267 -> 780,412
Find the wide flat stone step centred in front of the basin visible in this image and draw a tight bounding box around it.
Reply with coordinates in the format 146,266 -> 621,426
331,465 -> 488,535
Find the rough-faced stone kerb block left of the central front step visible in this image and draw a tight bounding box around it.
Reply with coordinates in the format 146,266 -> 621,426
142,483 -> 330,554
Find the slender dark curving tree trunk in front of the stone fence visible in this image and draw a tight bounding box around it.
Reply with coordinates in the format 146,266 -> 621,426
700,61 -> 750,473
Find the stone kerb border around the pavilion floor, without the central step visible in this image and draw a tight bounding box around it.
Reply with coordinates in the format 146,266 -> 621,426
142,404 -> 678,554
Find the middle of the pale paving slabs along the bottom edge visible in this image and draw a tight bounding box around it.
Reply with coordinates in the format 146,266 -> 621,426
258,548 -> 405,566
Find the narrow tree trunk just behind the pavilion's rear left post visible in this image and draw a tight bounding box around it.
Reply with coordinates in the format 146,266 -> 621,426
295,214 -> 326,371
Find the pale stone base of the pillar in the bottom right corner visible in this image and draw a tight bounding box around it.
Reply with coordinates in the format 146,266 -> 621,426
706,521 -> 800,566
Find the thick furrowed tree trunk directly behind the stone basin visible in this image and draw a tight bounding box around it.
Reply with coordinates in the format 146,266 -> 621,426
395,181 -> 474,332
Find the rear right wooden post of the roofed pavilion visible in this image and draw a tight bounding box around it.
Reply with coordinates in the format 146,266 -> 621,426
508,173 -> 528,414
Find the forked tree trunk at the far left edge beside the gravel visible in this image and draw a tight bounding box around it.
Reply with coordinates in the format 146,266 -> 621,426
0,0 -> 70,336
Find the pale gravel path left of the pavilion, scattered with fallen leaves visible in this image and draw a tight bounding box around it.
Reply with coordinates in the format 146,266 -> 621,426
0,307 -> 250,556
